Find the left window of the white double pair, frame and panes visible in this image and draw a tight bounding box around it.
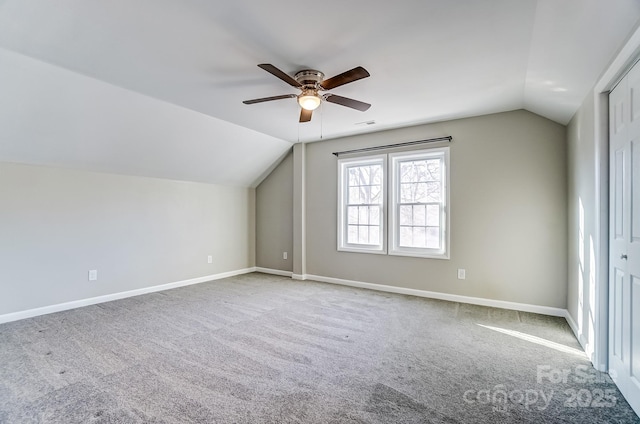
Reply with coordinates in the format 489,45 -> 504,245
338,156 -> 386,253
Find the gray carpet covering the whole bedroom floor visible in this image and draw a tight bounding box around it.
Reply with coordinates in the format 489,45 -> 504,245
0,273 -> 640,424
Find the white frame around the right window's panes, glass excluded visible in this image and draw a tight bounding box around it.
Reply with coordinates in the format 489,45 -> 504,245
388,147 -> 450,259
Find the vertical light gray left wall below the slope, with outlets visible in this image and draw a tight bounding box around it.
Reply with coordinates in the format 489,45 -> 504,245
0,163 -> 255,315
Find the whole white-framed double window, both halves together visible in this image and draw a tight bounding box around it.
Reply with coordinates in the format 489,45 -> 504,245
338,147 -> 449,259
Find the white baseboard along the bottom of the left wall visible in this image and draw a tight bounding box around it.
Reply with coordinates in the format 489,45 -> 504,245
0,267 -> 256,324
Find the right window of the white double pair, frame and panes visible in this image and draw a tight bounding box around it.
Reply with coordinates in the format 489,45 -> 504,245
389,148 -> 448,258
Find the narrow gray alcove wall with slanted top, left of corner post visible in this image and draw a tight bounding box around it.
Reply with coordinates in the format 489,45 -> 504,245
256,152 -> 293,271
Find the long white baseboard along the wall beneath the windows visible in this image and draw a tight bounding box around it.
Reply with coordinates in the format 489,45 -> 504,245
301,274 -> 567,318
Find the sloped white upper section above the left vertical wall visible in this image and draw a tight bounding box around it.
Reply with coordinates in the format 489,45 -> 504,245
0,45 -> 291,187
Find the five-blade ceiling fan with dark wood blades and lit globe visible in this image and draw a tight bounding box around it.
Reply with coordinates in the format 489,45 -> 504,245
242,63 -> 371,122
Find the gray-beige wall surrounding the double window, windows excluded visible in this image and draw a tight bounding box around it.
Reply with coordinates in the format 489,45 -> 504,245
258,110 -> 567,308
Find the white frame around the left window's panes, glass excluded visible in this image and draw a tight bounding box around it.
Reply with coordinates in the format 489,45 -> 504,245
338,155 -> 387,254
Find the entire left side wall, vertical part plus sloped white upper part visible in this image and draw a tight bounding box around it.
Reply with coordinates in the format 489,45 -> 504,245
0,44 -> 268,321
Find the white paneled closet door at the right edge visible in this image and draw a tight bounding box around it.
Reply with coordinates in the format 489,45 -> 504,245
609,58 -> 640,415
